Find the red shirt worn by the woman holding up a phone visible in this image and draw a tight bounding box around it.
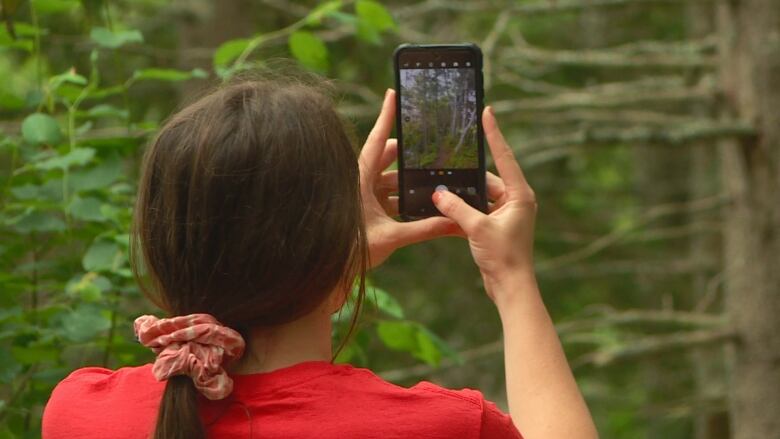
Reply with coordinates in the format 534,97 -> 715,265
43,361 -> 521,439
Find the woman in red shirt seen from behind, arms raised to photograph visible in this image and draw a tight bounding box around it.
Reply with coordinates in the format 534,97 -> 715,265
43,80 -> 596,439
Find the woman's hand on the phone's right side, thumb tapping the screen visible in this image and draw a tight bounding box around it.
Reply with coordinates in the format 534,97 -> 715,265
433,107 -> 537,305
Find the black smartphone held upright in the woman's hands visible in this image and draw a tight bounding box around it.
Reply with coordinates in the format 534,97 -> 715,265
393,44 -> 487,221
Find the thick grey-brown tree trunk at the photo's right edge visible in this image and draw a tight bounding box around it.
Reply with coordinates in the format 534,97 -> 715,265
718,0 -> 780,439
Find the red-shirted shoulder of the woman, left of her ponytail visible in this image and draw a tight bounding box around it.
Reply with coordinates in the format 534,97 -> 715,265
42,364 -> 164,438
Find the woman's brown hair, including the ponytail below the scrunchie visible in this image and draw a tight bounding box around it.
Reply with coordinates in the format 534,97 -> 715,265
131,78 -> 368,439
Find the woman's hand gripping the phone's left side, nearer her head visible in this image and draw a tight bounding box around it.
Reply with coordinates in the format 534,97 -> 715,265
359,89 -> 462,268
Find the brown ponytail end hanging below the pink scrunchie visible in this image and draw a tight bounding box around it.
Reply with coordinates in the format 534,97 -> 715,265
153,375 -> 206,439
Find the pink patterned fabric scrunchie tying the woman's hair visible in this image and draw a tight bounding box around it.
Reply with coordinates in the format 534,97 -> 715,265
133,314 -> 245,400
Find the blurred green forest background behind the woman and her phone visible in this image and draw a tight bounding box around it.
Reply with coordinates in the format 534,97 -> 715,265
0,0 -> 780,439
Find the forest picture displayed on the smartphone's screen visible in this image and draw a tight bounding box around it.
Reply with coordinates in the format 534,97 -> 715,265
400,68 -> 479,169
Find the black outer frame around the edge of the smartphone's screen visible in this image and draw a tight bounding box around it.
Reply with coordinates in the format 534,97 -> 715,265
393,43 -> 487,221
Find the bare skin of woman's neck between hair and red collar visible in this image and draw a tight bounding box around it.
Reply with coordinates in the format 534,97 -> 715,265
227,306 -> 332,375
